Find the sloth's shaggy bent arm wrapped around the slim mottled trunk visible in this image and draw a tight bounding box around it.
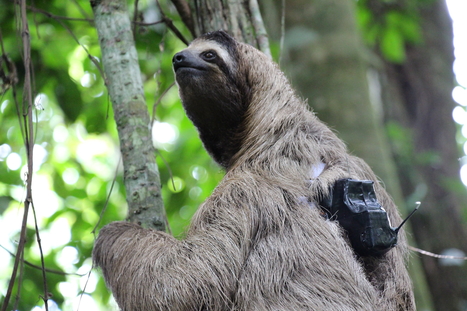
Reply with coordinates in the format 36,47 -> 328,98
93,199 -> 248,310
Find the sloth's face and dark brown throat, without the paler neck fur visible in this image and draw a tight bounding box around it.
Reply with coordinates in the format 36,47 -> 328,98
172,31 -> 254,167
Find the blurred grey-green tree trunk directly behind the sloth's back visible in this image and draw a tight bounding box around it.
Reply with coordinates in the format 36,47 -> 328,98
276,0 -> 431,309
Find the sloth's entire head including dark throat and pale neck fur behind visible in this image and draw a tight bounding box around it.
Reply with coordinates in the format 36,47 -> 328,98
172,31 -> 297,168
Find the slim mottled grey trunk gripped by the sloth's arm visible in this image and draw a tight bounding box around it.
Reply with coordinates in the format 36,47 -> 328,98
91,0 -> 167,231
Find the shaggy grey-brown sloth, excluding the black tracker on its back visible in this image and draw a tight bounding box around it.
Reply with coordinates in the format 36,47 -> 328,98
93,31 -> 415,311
